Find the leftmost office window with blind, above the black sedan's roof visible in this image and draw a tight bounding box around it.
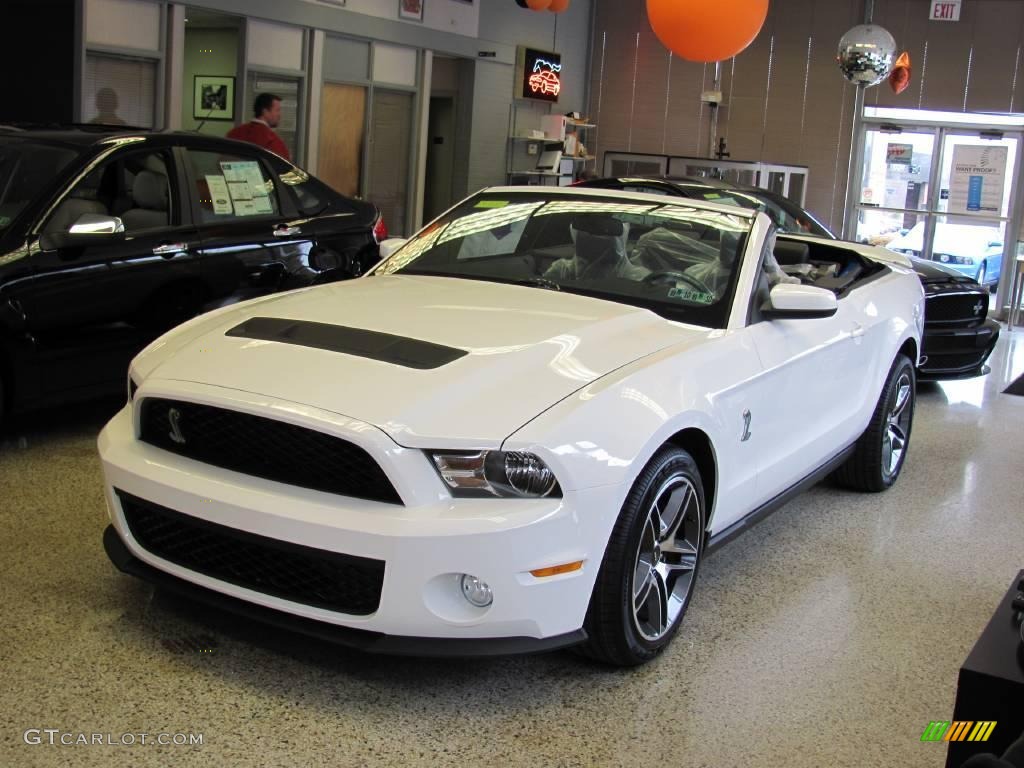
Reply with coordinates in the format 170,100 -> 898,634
82,52 -> 157,128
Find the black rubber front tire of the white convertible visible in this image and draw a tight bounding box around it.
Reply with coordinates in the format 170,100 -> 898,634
579,446 -> 707,667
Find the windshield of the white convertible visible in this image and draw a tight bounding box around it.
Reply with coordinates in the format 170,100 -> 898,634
374,191 -> 753,328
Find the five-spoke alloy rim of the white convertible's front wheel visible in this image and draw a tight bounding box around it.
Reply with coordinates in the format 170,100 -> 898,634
632,475 -> 703,642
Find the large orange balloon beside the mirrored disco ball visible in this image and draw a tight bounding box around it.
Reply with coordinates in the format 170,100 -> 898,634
647,0 -> 768,61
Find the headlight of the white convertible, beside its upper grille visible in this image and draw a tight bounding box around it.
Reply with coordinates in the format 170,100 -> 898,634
430,451 -> 562,499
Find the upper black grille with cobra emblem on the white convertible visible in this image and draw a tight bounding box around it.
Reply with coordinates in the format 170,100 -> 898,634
141,397 -> 401,504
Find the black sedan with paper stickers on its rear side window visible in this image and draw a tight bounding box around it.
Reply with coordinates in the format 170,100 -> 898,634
0,126 -> 386,428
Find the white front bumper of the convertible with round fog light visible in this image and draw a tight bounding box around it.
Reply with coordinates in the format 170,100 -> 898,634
99,399 -> 622,655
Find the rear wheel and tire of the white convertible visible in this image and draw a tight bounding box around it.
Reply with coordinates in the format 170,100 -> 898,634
834,354 -> 918,493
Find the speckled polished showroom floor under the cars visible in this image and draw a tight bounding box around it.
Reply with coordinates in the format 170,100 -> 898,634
0,331 -> 1024,768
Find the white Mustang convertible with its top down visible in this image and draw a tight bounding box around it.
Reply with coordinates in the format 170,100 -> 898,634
99,187 -> 924,665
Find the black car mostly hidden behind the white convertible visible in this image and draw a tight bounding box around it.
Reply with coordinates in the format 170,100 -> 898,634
577,176 -> 999,380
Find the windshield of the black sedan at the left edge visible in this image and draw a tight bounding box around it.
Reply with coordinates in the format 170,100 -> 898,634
0,136 -> 78,231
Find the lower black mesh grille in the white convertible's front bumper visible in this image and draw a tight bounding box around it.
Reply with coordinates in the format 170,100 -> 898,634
118,490 -> 384,615
